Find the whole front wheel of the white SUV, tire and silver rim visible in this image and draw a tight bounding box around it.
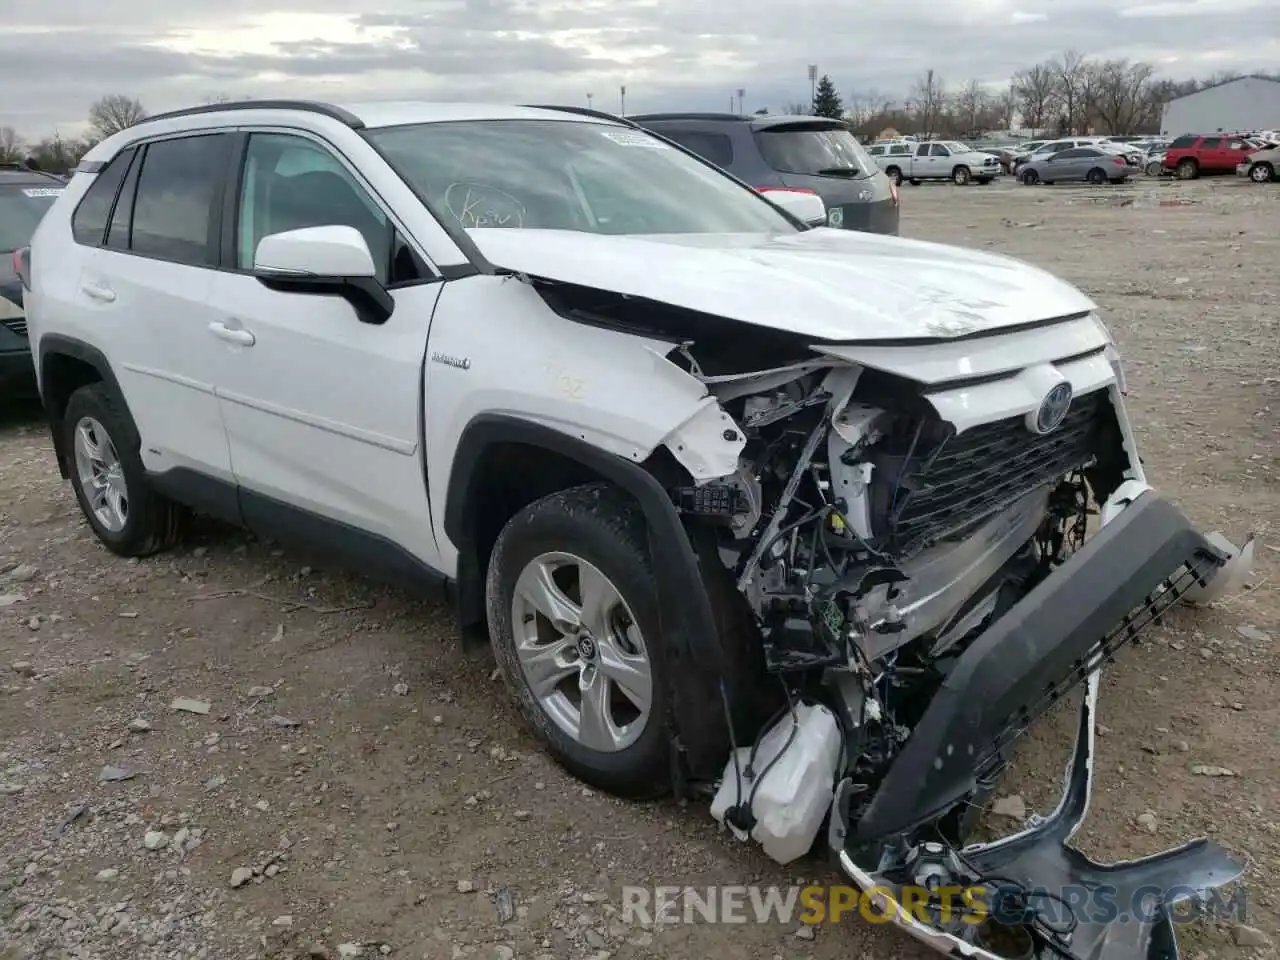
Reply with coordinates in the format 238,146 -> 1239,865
485,484 -> 669,797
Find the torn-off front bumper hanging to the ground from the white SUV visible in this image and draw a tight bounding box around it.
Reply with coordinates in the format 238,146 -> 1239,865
828,490 -> 1243,960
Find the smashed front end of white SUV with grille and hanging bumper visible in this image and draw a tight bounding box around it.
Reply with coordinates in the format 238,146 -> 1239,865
634,312 -> 1252,960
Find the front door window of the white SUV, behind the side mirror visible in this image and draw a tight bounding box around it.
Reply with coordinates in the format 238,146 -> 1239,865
236,133 -> 393,283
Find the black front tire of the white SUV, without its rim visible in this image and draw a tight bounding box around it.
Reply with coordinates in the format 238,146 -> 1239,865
485,483 -> 671,799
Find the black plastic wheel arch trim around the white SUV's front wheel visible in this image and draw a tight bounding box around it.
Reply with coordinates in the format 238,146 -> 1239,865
444,415 -> 727,792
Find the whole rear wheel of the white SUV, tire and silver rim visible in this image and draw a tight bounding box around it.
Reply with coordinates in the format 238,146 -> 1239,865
63,383 -> 187,557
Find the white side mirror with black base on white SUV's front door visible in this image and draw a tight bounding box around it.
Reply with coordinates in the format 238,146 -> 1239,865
253,225 -> 396,324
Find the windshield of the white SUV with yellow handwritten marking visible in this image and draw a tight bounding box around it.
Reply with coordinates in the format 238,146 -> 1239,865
366,120 -> 799,236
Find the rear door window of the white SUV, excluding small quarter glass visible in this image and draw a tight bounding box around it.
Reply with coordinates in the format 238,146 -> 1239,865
129,133 -> 230,266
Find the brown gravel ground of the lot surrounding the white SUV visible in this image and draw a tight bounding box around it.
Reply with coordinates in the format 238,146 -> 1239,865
0,180 -> 1280,960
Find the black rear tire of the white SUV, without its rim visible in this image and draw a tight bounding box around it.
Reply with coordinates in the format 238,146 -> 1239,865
63,383 -> 188,557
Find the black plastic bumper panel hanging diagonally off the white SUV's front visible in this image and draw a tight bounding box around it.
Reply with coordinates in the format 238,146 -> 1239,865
858,493 -> 1226,841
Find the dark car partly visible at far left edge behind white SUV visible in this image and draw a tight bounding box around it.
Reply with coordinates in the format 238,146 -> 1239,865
0,163 -> 67,397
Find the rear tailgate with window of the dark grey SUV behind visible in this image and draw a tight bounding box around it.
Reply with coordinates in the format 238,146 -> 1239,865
753,118 -> 897,233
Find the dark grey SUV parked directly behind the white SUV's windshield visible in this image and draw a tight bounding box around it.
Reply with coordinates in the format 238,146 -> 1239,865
627,113 -> 899,236
